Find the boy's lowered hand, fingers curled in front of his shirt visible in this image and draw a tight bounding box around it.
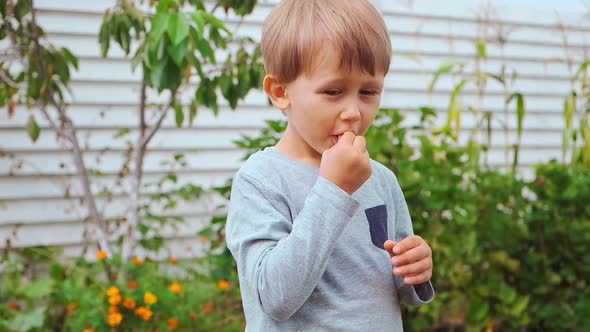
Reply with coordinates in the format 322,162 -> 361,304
383,235 -> 432,285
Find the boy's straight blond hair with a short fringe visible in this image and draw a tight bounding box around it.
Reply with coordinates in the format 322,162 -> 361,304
261,0 -> 391,84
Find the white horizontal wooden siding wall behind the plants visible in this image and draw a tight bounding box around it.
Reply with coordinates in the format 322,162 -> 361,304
0,0 -> 590,256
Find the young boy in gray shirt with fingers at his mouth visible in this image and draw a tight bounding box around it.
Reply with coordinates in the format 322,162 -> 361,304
226,0 -> 434,331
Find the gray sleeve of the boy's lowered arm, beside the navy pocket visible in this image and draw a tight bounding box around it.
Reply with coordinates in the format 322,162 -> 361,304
391,173 -> 434,306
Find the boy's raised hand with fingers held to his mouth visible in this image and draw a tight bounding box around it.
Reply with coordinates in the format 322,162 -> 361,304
320,131 -> 372,195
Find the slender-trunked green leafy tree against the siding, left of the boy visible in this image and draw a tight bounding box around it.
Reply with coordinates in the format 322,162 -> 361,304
0,0 -> 262,260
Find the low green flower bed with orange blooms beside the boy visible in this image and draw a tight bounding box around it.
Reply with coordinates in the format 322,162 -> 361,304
0,248 -> 244,331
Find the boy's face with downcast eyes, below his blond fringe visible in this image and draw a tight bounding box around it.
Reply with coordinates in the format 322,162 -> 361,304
277,47 -> 385,166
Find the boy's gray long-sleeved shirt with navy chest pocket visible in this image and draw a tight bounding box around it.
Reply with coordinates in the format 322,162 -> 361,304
226,148 -> 434,331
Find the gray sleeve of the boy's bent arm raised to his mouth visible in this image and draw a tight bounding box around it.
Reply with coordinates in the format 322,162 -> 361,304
226,173 -> 360,320
